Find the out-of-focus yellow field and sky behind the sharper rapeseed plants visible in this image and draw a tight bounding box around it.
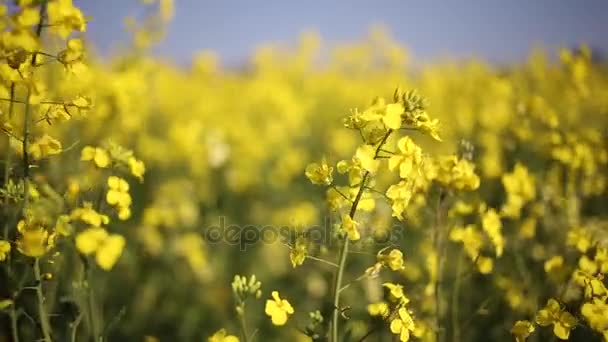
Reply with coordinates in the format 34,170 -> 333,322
0,0 -> 608,342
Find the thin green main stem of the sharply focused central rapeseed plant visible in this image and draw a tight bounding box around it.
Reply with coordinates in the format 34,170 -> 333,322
331,129 -> 393,342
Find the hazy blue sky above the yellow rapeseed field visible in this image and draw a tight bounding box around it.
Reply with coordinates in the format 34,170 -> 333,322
74,0 -> 608,64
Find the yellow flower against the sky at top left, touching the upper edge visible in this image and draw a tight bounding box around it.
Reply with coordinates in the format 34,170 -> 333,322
47,0 -> 87,39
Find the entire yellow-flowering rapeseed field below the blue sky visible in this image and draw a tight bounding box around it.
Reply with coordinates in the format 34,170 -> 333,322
0,0 -> 608,342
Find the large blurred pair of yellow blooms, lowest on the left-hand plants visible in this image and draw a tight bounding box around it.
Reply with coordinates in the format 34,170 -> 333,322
76,227 -> 126,271
